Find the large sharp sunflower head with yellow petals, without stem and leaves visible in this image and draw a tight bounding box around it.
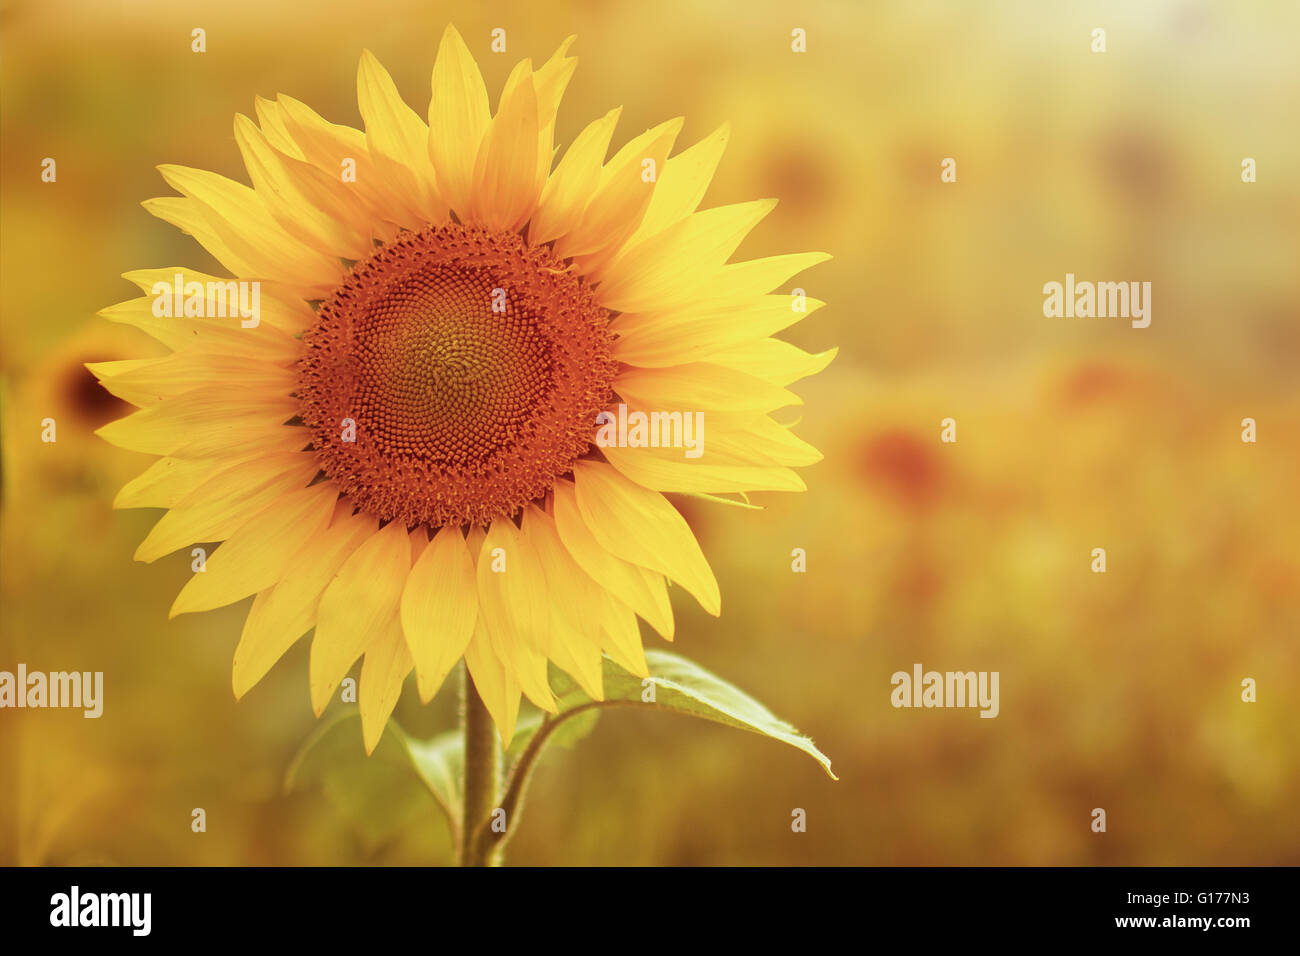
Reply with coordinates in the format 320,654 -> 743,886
90,27 -> 833,750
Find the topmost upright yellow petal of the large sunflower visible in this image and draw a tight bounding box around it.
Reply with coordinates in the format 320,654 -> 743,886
429,25 -> 488,218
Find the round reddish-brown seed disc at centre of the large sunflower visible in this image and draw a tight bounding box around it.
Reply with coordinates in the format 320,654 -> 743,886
296,224 -> 615,528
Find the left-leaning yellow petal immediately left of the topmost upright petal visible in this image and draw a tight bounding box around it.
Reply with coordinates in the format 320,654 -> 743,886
356,49 -> 447,229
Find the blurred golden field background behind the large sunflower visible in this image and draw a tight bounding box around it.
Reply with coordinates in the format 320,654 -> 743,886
0,0 -> 1300,865
